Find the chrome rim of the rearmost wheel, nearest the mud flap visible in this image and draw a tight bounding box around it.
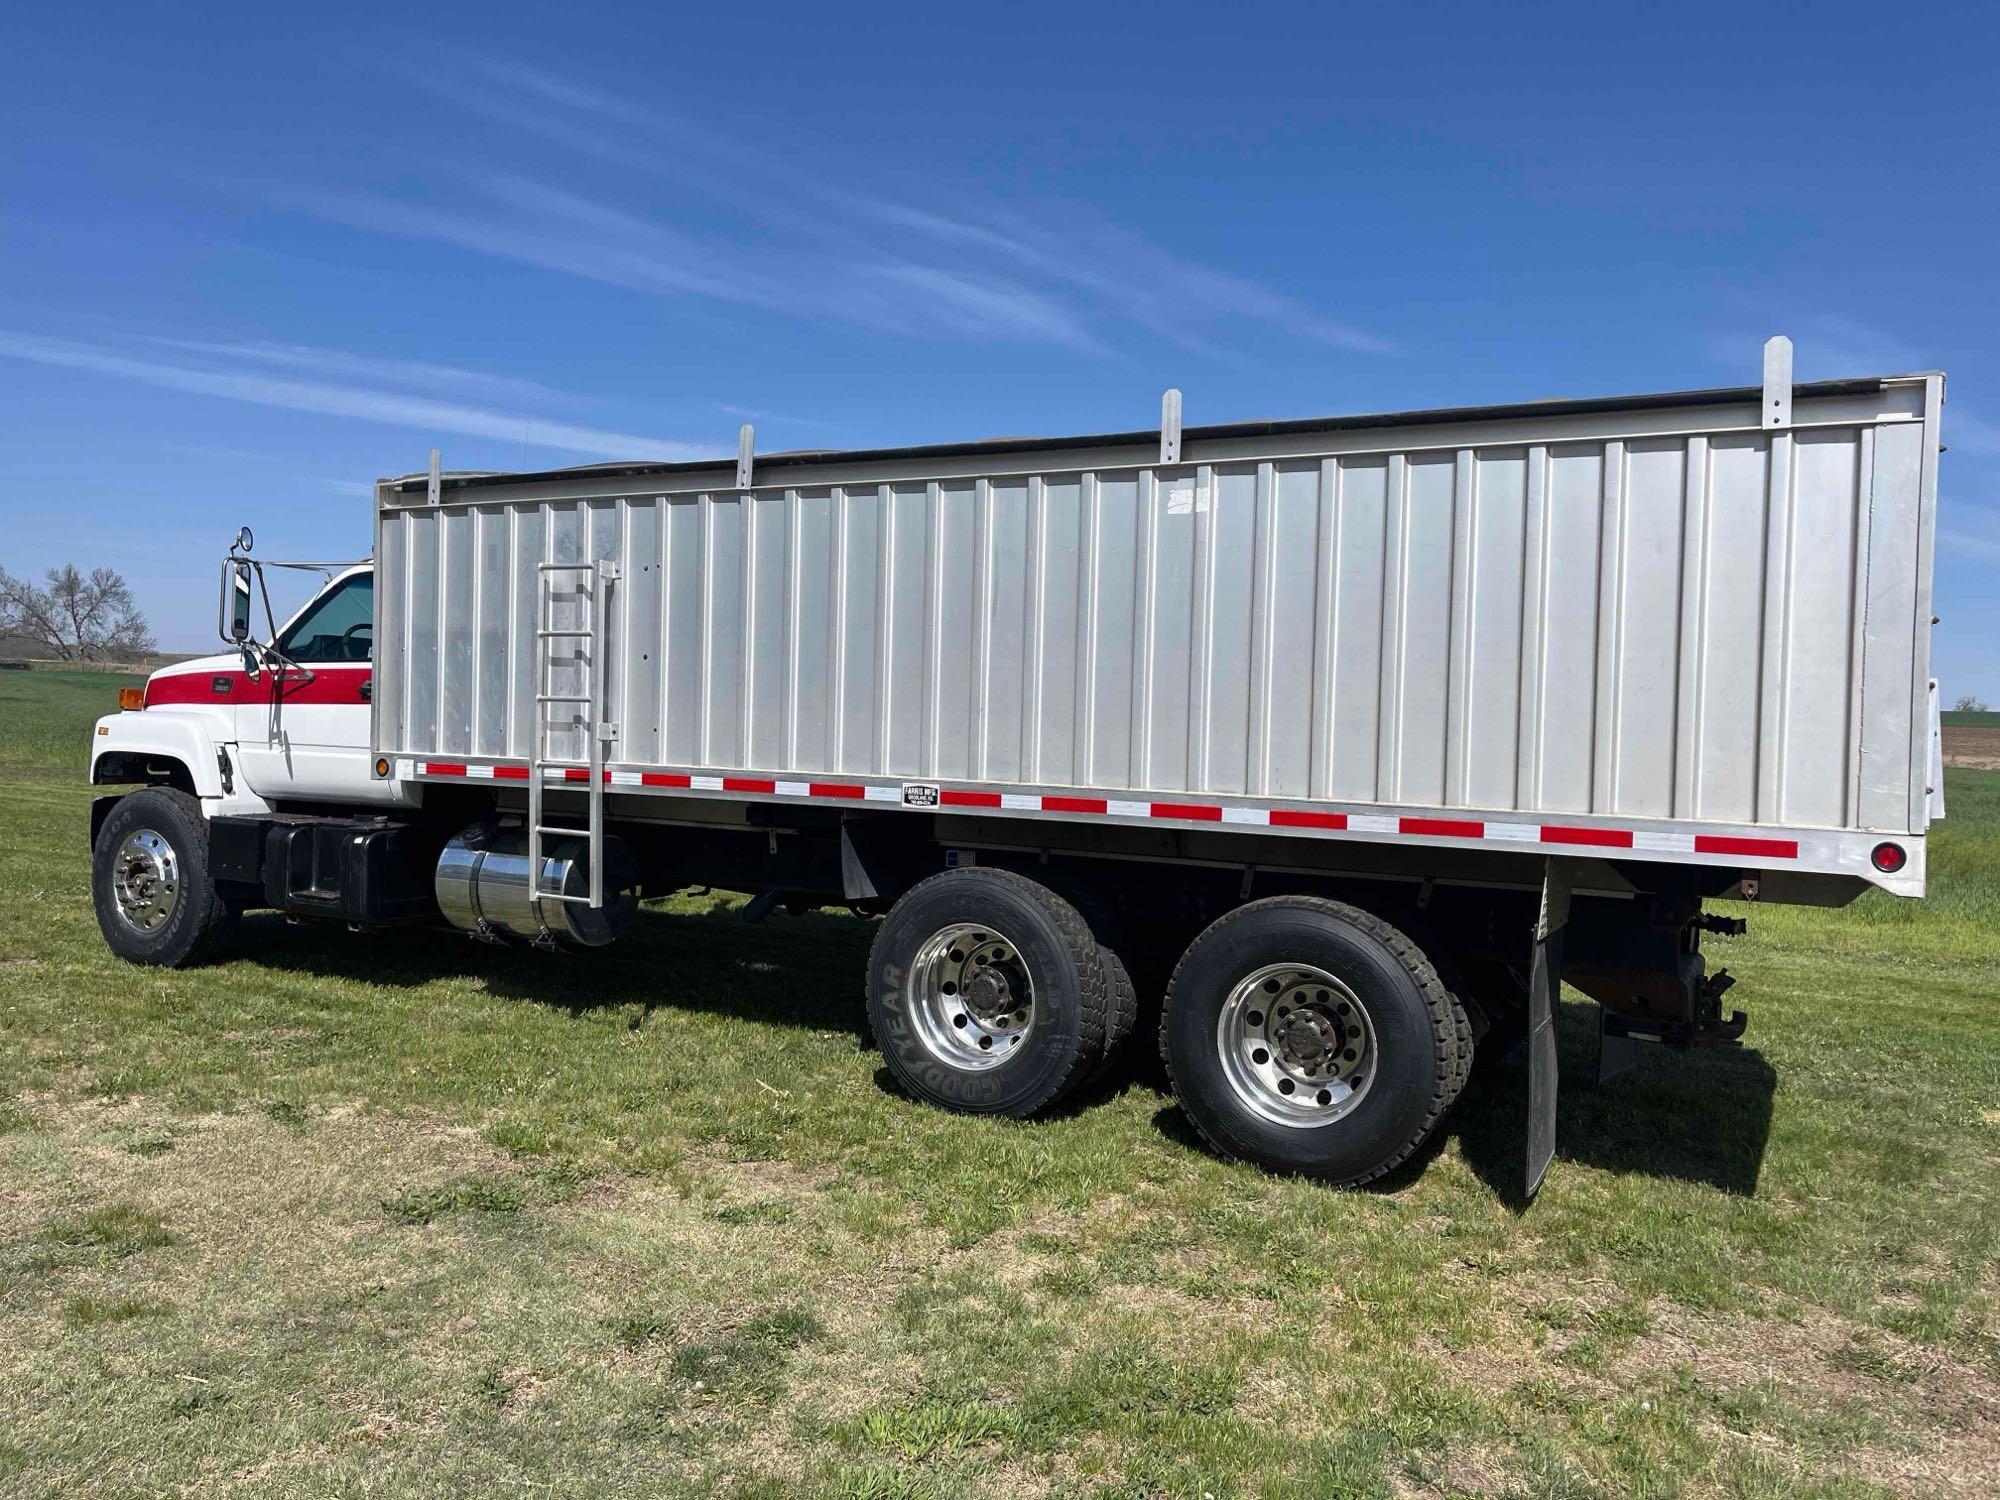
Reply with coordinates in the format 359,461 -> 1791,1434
1216,964 -> 1376,1130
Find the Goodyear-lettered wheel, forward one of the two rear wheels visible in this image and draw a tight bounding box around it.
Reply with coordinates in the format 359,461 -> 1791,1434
868,866 -> 1106,1120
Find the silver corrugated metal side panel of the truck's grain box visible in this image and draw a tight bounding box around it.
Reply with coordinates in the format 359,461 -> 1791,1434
378,386 -> 1936,832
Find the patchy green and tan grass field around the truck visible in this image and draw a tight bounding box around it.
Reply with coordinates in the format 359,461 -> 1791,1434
0,672 -> 2000,1498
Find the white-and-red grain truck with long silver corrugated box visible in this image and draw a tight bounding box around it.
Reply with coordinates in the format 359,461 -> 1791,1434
90,340 -> 1944,1190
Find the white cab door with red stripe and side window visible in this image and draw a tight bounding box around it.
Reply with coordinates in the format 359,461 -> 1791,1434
236,568 -> 394,802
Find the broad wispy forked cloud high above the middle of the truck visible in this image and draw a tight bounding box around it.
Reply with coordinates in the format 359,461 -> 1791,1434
312,60 -> 1390,354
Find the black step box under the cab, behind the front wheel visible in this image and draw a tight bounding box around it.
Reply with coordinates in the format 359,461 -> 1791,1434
208,814 -> 438,926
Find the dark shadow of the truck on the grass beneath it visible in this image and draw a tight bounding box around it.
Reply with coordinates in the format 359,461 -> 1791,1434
238,904 -> 1778,1210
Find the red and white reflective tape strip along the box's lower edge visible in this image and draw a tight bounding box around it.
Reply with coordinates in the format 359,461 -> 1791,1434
400,760 -> 1798,860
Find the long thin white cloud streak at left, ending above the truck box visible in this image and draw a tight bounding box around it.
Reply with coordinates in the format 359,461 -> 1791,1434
0,330 -> 712,460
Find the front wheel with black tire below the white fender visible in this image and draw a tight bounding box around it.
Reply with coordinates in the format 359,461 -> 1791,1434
90,786 -> 238,968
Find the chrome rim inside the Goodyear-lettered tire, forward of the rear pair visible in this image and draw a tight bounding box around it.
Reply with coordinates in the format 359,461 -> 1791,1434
904,922 -> 1034,1072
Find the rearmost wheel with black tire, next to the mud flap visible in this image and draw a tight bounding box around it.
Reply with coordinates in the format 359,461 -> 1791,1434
1160,896 -> 1468,1186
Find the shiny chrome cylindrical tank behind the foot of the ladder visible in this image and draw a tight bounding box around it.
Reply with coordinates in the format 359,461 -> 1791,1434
436,822 -> 638,948
